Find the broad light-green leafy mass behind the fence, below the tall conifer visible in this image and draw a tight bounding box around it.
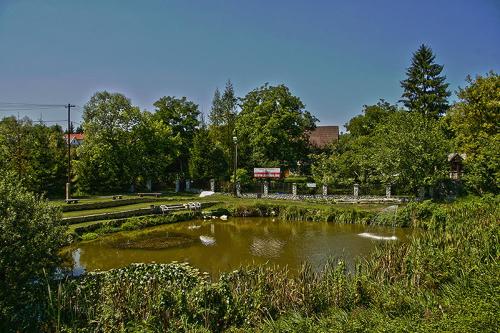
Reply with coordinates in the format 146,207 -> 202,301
312,101 -> 450,194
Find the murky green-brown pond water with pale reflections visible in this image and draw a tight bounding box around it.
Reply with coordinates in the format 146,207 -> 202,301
68,218 -> 411,276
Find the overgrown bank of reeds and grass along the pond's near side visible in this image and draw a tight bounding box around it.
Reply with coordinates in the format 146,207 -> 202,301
44,198 -> 500,332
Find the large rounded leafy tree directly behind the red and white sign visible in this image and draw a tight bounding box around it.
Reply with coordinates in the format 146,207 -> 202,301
236,84 -> 317,169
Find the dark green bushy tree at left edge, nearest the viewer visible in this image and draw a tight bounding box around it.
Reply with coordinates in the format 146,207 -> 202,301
0,172 -> 66,332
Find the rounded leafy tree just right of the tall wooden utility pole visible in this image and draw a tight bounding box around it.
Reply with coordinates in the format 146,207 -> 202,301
75,91 -> 141,193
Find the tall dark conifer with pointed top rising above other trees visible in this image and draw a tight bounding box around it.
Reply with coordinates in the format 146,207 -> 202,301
401,44 -> 451,118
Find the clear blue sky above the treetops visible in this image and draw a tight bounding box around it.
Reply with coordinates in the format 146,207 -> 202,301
0,0 -> 500,126
